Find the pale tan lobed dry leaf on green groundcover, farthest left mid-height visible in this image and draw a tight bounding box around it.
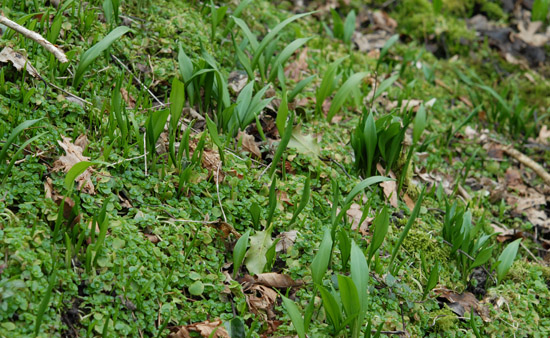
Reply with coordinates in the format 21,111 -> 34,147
52,136 -> 95,195
